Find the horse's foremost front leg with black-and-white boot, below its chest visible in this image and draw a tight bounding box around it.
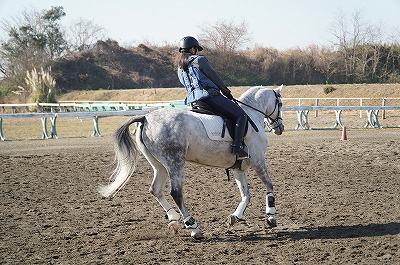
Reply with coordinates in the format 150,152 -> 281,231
254,161 -> 276,227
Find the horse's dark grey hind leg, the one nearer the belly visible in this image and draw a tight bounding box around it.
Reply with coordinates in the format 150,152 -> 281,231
171,170 -> 204,239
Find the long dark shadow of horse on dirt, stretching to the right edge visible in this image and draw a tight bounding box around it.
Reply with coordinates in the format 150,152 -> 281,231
206,222 -> 400,242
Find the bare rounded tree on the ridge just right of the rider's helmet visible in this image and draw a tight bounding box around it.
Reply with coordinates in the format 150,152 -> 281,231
200,21 -> 251,53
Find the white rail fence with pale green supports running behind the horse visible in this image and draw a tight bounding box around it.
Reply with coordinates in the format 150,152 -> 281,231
0,98 -> 400,141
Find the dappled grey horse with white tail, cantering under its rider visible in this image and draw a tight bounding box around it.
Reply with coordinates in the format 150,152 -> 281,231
98,86 -> 284,239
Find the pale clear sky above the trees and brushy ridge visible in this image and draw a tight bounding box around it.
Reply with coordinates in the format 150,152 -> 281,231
0,0 -> 400,50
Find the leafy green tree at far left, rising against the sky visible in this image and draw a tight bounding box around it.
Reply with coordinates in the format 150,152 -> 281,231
0,6 -> 67,93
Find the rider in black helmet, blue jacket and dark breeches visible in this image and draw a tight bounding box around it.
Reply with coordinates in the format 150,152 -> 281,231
178,36 -> 248,158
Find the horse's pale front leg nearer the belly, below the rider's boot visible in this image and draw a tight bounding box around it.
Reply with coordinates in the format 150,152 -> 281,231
228,169 -> 250,226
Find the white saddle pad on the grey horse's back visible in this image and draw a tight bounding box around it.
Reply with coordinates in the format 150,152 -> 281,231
192,112 -> 232,142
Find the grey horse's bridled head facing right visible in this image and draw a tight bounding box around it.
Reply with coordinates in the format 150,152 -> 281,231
265,85 -> 285,135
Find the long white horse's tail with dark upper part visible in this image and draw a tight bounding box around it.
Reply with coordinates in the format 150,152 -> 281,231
98,116 -> 145,197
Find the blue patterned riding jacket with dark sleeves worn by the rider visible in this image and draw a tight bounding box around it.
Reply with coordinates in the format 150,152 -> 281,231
178,55 -> 230,104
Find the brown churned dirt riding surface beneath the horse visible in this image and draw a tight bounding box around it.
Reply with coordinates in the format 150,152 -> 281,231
0,126 -> 400,264
